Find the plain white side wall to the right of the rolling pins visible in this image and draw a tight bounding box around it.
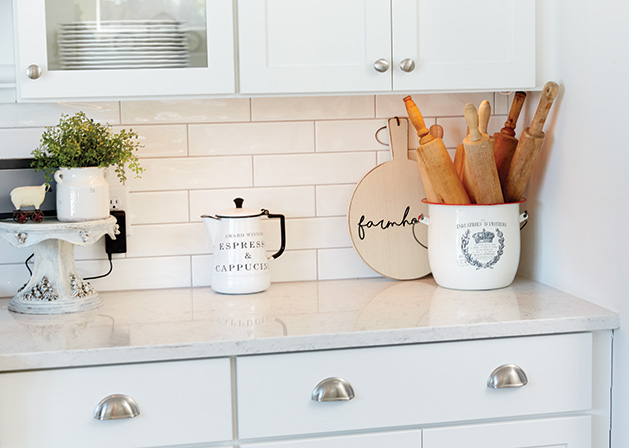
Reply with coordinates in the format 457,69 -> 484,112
520,0 -> 629,448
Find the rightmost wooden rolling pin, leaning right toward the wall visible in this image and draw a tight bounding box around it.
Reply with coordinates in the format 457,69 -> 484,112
504,81 -> 559,202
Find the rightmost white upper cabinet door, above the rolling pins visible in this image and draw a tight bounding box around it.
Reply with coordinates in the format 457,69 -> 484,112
392,0 -> 535,91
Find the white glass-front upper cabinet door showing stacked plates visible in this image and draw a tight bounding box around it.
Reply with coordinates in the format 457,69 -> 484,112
14,0 -> 235,100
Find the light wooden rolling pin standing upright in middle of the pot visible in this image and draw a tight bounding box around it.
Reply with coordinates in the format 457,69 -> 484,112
463,103 -> 504,204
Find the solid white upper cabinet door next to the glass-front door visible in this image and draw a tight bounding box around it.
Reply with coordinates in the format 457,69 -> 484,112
238,0 -> 391,94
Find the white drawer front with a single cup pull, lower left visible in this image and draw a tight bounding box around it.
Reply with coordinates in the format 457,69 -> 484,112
0,359 -> 232,448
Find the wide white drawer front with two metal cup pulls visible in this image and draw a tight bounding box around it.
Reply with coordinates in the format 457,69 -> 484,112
237,333 -> 592,438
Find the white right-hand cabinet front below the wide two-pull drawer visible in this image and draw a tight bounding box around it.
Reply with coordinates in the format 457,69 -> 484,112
422,416 -> 592,448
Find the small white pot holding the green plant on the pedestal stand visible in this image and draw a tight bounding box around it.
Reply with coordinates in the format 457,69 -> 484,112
55,168 -> 109,221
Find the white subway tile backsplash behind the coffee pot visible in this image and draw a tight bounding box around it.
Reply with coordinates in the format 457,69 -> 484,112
0,93 -> 506,297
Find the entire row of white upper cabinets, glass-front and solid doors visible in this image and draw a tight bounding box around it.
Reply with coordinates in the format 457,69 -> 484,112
7,0 -> 540,102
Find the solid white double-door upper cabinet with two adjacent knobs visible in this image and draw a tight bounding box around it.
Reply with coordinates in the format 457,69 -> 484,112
238,0 -> 536,94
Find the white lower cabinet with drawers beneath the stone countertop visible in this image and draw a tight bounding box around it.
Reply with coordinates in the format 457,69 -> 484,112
0,332 -> 611,448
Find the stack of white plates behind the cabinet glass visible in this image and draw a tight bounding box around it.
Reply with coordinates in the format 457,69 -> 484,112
57,20 -> 190,70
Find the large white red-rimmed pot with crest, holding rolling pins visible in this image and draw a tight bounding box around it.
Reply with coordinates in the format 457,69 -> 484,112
419,200 -> 528,290
